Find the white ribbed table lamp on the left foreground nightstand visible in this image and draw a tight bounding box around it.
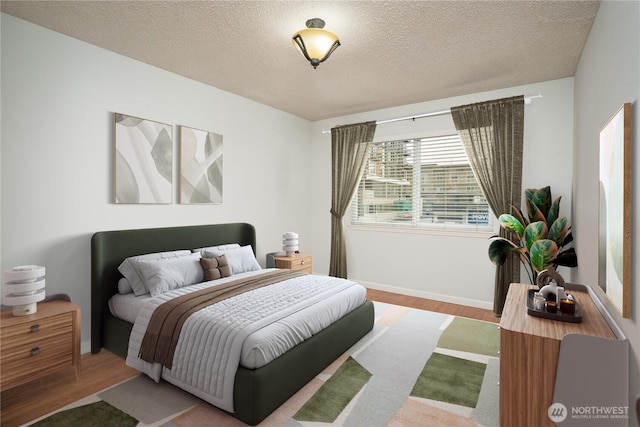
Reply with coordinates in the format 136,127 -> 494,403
2,265 -> 45,316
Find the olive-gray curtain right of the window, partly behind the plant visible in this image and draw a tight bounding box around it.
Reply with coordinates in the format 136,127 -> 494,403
451,96 -> 524,315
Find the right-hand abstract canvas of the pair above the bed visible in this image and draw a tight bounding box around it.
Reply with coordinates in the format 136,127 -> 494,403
180,126 -> 222,204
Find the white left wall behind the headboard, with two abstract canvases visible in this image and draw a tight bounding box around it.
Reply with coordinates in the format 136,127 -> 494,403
1,14 -> 311,350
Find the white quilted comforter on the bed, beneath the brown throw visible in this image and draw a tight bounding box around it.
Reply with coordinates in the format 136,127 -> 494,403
127,272 -> 366,412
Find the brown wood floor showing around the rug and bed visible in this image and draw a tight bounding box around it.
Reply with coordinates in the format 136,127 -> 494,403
0,289 -> 500,427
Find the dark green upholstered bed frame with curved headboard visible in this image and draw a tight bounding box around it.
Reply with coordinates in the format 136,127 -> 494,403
91,223 -> 374,425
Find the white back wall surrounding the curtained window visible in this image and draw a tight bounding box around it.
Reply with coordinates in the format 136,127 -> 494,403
311,78 -> 573,308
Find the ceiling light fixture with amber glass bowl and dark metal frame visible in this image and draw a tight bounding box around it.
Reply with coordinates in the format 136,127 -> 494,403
293,18 -> 340,68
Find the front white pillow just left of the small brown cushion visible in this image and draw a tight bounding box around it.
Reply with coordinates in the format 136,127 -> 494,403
138,253 -> 204,297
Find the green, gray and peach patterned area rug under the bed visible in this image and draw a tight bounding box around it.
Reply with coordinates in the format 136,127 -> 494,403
27,302 -> 500,427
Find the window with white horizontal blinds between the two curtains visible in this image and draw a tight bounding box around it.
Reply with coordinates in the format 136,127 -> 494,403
351,135 -> 493,232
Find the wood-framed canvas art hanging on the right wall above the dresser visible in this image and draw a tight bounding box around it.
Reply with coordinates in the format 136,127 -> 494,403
598,103 -> 631,318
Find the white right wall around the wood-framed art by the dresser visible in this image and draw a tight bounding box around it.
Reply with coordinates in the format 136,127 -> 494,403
574,1 -> 640,425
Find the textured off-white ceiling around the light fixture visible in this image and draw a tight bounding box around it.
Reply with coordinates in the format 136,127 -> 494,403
1,0 -> 600,120
